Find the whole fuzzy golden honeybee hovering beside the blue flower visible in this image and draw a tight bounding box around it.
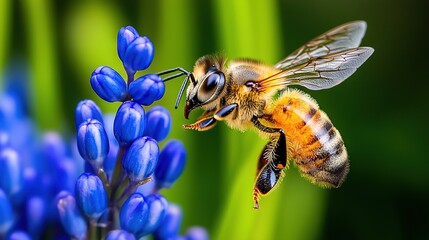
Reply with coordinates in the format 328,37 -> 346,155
158,21 -> 374,208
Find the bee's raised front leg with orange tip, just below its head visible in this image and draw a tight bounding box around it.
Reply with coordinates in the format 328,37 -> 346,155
183,103 -> 238,131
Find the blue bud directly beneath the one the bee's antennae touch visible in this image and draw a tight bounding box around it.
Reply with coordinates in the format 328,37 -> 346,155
143,106 -> 171,142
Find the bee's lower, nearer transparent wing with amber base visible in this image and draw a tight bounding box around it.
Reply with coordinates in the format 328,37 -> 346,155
258,47 -> 374,91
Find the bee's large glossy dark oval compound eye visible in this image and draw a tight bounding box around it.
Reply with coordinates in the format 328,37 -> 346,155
198,72 -> 225,103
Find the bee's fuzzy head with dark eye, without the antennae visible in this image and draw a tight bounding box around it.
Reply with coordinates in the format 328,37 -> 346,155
184,56 -> 226,119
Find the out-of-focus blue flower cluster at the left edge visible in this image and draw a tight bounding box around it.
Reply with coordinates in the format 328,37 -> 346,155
0,61 -> 83,239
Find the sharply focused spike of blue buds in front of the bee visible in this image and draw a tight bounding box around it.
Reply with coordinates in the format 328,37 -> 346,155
56,26 -> 208,239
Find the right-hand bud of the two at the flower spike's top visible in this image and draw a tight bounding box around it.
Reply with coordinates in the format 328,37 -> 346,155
122,37 -> 154,71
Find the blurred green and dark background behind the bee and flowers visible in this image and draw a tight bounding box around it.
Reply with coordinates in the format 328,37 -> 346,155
0,0 -> 429,239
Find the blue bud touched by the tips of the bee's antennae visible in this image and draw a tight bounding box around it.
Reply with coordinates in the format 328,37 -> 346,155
128,74 -> 165,106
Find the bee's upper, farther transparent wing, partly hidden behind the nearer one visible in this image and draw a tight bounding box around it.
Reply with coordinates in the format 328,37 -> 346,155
275,21 -> 366,70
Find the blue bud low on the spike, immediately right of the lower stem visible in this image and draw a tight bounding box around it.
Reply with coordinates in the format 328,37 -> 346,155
119,193 -> 149,234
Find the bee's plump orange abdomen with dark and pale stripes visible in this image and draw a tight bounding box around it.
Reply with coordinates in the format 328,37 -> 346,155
270,90 -> 349,187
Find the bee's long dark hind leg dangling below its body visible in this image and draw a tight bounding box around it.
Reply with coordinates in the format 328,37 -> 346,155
252,117 -> 287,208
